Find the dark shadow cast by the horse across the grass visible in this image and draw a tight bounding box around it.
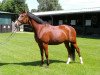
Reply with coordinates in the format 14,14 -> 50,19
0,60 -> 66,66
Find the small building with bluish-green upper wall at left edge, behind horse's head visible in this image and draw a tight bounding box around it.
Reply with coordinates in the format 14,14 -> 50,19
0,11 -> 17,33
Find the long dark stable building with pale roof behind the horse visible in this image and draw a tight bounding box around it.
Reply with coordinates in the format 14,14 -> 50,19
27,7 -> 100,35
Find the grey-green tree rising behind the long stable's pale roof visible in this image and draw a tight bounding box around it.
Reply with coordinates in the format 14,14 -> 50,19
37,0 -> 62,11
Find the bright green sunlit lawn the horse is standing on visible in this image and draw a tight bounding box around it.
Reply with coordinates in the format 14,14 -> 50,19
0,33 -> 100,75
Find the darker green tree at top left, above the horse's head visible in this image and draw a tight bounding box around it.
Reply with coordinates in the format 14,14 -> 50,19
0,0 -> 28,13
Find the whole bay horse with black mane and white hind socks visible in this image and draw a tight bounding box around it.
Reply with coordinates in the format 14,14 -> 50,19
15,12 -> 83,66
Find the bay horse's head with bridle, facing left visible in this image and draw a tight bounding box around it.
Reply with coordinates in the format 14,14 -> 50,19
15,12 -> 29,27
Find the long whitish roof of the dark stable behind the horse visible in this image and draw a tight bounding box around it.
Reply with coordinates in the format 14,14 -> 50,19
33,7 -> 100,16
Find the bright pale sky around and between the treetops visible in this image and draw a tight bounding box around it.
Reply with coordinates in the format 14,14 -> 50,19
0,0 -> 100,10
